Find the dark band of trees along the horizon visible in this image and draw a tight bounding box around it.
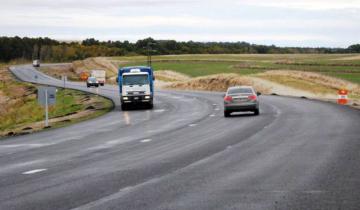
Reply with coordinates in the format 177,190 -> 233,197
0,36 -> 360,62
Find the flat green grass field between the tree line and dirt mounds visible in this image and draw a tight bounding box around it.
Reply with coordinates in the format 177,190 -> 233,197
109,54 -> 360,84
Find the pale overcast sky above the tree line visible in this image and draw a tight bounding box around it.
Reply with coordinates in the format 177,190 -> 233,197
0,0 -> 360,47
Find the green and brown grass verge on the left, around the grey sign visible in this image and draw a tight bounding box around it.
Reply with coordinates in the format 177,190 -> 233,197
0,64 -> 113,137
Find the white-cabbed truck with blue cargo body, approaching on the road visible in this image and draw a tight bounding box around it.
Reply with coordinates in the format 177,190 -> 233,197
117,66 -> 155,110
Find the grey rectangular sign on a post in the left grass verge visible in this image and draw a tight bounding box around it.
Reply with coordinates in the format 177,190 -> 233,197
38,86 -> 56,127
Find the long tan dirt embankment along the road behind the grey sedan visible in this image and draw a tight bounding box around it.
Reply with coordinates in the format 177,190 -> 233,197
158,70 -> 360,105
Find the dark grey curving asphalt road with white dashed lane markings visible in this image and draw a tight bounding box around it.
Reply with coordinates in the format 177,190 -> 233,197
0,66 -> 360,210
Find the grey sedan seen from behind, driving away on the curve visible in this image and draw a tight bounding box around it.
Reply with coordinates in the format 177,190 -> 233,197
224,86 -> 261,117
